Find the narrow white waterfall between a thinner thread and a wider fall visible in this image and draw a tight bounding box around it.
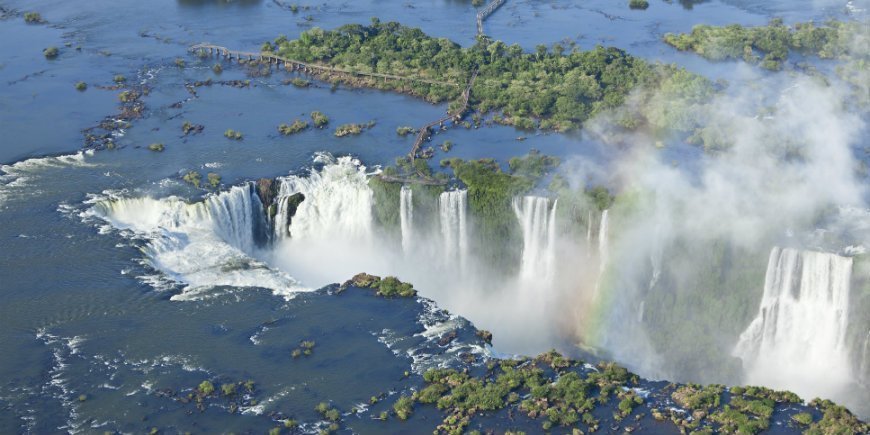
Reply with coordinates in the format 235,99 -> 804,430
438,190 -> 468,269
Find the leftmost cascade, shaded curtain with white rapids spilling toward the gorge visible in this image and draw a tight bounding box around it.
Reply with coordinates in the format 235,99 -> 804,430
86,184 -> 303,298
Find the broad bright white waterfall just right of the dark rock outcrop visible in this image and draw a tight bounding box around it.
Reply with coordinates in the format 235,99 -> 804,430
275,156 -> 373,242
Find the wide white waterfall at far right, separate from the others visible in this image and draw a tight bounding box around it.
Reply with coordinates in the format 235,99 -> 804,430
733,248 -> 852,395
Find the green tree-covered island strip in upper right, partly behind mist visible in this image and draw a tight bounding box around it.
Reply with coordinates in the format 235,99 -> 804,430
664,19 -> 870,70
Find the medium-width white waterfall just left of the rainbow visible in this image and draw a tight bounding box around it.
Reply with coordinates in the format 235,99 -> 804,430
513,196 -> 558,282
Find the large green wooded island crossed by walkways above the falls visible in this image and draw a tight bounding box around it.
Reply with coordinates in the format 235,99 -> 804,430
275,19 -> 716,130
